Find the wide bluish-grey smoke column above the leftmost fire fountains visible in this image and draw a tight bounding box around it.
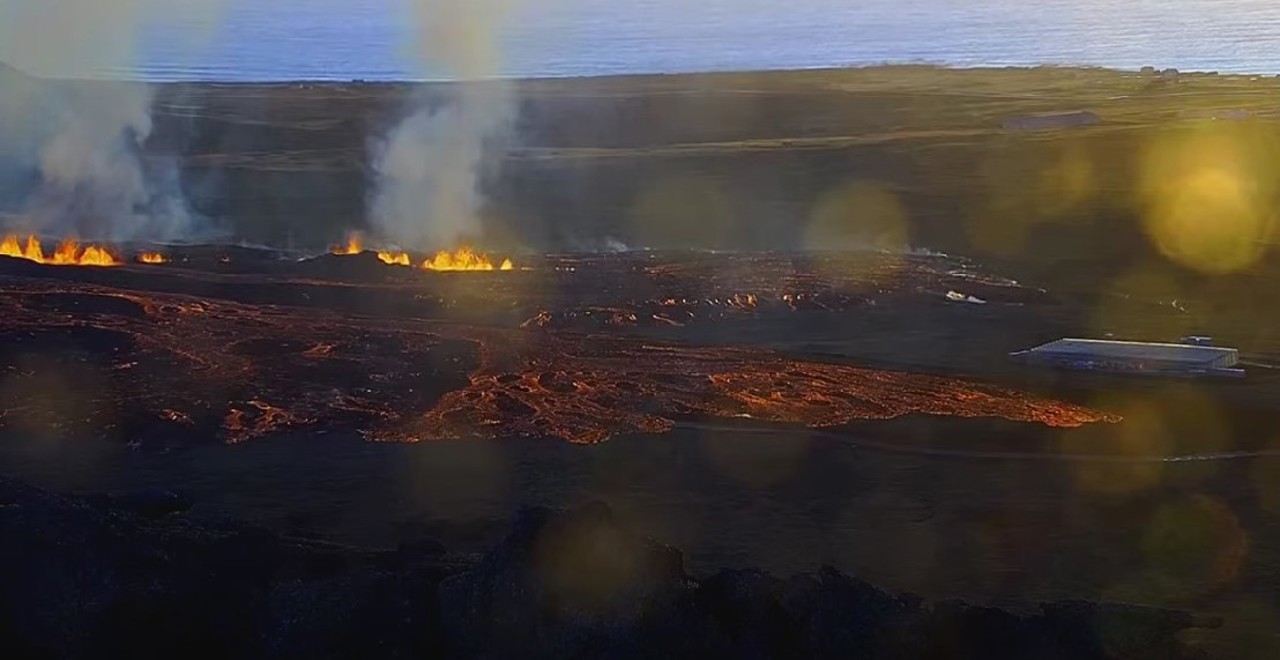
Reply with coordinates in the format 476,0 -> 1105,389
0,0 -> 220,240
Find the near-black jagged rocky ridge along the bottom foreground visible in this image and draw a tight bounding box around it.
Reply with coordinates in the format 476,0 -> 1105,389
0,478 -> 1215,660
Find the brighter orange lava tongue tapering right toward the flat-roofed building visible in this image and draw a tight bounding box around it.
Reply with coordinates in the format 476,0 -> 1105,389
381,326 -> 1119,444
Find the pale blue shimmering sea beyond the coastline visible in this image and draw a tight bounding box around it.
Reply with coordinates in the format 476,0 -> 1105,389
100,0 -> 1280,81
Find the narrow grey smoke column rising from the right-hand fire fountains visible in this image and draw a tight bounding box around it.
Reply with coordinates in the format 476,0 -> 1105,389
370,0 -> 517,249
